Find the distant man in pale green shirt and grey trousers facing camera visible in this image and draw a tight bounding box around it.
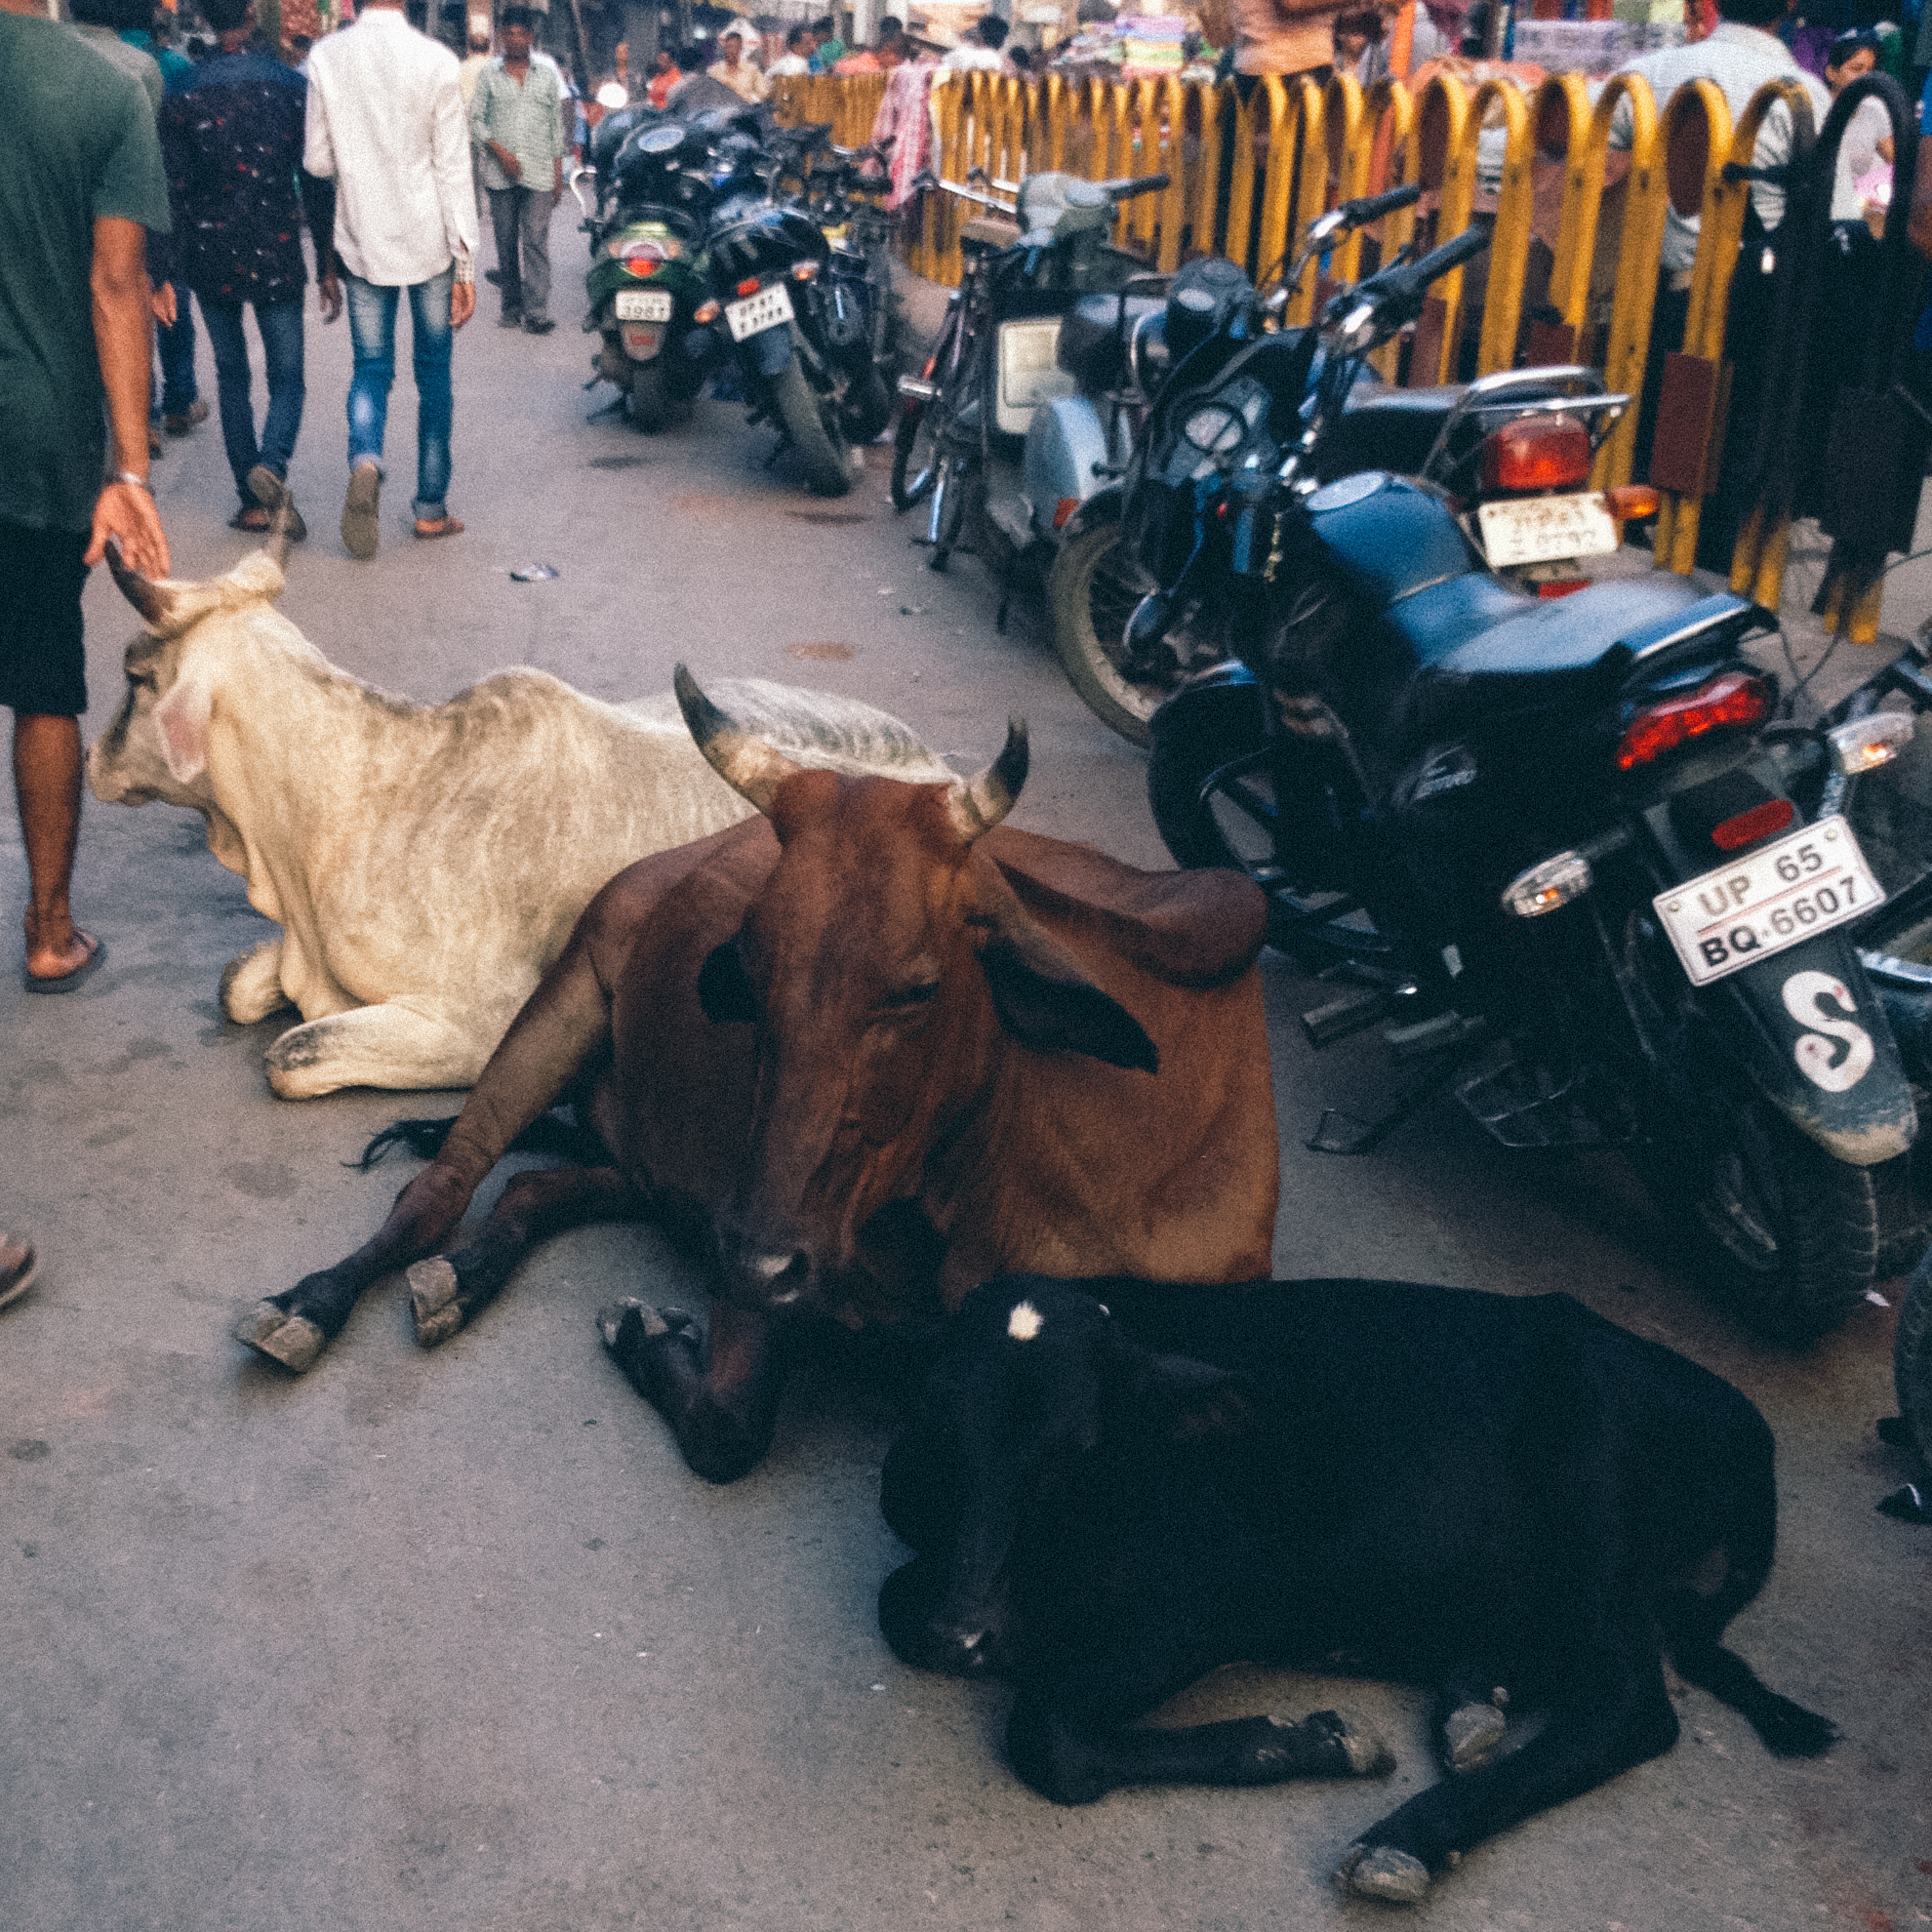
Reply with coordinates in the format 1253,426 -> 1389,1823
469,6 -> 570,337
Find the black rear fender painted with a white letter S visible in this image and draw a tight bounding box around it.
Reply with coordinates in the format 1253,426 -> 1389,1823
1698,931 -> 1918,1167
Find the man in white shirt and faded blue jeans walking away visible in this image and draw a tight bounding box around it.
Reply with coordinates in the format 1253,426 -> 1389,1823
303,0 -> 477,558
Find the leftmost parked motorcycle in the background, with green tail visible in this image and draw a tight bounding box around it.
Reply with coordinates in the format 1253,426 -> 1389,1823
570,108 -> 738,431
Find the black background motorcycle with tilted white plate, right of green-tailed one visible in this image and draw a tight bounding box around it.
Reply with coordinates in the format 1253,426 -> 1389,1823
709,128 -> 891,497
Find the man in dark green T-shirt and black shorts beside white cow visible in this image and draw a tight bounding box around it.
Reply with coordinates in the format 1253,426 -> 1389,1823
0,0 -> 168,993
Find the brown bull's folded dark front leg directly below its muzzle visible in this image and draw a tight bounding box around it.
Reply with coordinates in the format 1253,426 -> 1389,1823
597,1301 -> 785,1482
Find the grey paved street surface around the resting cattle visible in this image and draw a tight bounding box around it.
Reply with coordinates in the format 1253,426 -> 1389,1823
0,217 -> 1932,1932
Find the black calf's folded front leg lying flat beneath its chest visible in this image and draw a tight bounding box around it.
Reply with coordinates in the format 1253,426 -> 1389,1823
1007,1691 -> 1395,1804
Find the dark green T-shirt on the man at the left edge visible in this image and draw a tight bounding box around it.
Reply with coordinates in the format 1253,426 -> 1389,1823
0,12 -> 168,530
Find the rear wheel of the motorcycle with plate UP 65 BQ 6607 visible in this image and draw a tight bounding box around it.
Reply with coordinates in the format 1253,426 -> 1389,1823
1638,1090 -> 1878,1348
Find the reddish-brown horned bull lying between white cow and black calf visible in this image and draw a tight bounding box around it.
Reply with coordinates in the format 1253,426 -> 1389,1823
240,666 -> 1279,1482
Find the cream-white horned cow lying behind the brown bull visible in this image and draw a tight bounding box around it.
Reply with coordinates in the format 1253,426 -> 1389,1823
87,544 -> 952,1100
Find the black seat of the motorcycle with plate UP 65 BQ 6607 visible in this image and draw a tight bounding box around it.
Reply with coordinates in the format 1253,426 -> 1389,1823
1389,570 -> 1706,742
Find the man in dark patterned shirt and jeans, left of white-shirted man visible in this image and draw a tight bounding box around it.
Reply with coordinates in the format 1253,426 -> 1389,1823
160,0 -> 337,541
